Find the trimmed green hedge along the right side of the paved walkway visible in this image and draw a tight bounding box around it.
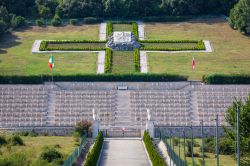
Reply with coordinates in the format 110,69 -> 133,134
143,131 -> 166,166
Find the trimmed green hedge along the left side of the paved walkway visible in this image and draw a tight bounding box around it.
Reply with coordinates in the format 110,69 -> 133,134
84,132 -> 103,166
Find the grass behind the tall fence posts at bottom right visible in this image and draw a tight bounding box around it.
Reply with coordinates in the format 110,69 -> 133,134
165,139 -> 236,166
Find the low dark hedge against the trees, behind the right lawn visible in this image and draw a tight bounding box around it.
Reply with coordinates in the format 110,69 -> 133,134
142,16 -> 192,22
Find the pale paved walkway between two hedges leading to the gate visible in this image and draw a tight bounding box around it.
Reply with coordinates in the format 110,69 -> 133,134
99,139 -> 150,166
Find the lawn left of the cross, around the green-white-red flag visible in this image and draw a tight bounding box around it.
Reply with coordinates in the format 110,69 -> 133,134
0,25 -> 99,75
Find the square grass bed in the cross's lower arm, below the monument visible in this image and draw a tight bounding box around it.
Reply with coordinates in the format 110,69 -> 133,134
112,51 -> 135,74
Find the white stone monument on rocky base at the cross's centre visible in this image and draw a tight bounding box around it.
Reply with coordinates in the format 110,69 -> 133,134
106,32 -> 141,51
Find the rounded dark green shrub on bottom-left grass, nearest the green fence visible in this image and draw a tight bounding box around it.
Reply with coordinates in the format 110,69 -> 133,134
40,148 -> 63,163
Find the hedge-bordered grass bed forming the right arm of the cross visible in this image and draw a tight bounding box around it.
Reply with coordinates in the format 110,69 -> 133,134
141,40 -> 205,51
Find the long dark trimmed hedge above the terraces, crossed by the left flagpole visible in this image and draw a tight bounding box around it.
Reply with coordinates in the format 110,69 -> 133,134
0,73 -> 187,84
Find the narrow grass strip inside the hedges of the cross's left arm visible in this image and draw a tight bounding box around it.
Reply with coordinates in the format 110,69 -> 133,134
47,43 -> 106,50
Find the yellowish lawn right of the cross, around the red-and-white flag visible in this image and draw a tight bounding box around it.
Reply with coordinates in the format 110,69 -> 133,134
145,19 -> 250,80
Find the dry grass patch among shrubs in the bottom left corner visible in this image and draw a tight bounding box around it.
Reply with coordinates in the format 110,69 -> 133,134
0,136 -> 77,163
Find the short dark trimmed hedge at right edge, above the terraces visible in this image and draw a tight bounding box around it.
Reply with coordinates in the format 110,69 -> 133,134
202,74 -> 250,84
